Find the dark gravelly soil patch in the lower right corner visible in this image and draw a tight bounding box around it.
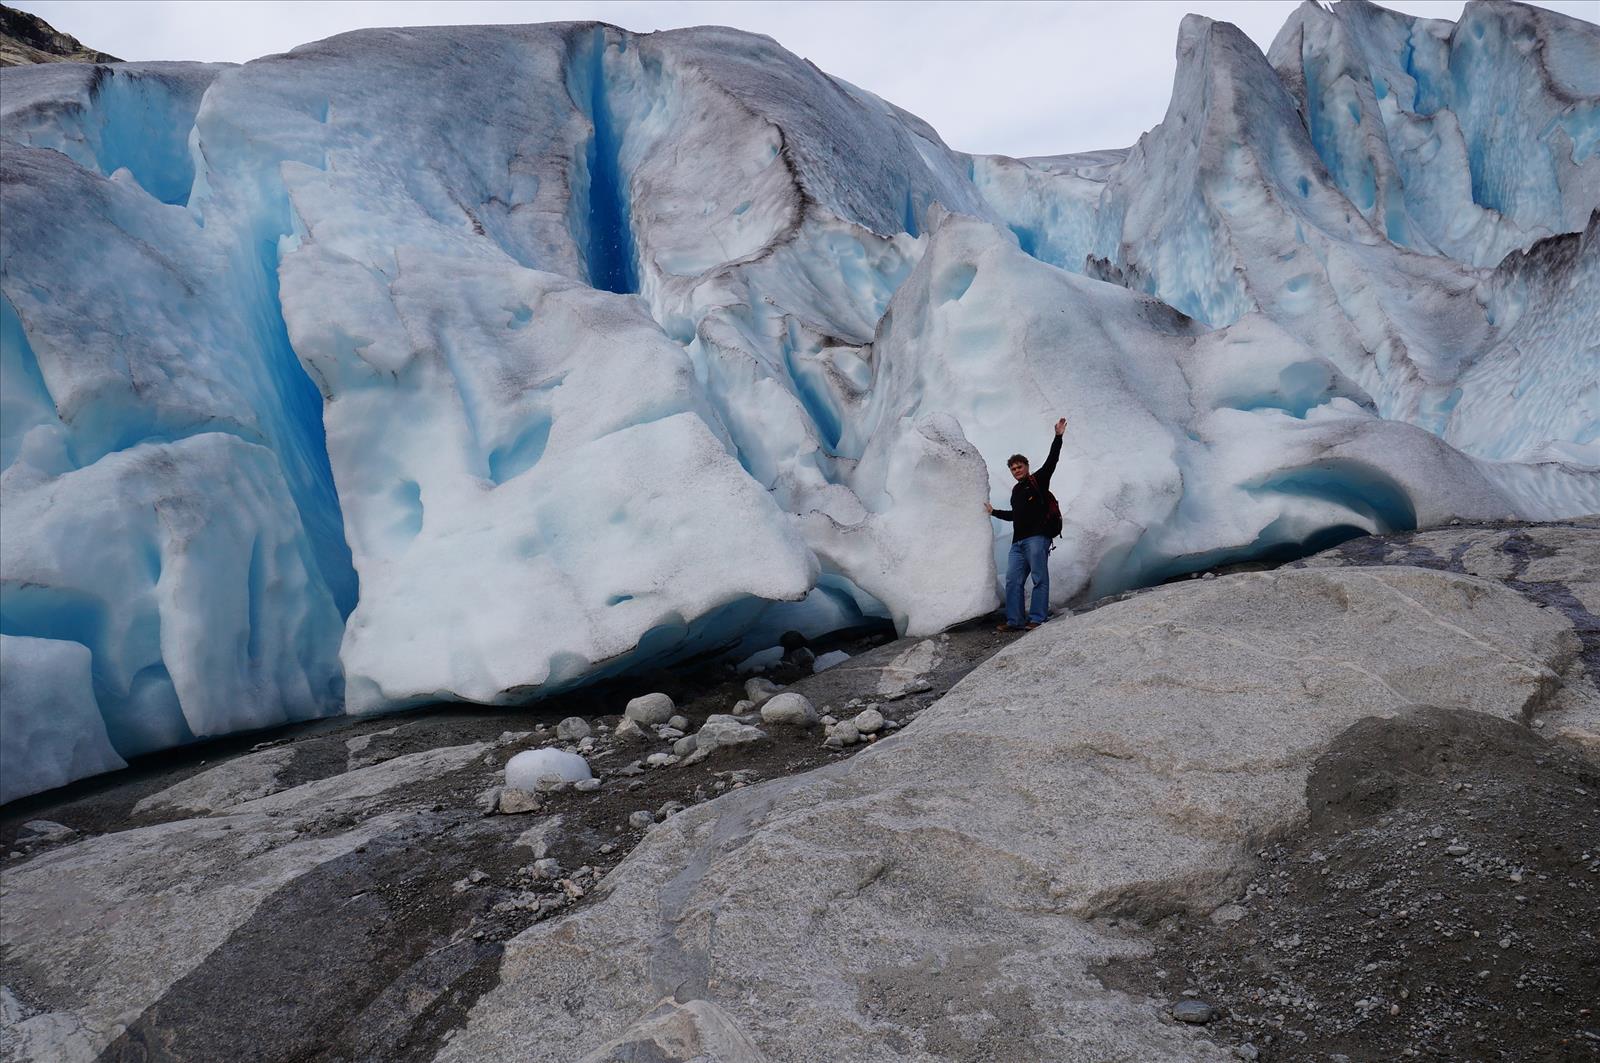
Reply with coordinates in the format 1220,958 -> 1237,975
1102,708 -> 1600,1061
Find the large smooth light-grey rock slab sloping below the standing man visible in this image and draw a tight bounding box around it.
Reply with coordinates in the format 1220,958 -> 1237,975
440,568 -> 1578,1063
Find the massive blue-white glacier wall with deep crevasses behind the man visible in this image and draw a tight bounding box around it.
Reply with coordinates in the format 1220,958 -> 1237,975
0,0 -> 1600,800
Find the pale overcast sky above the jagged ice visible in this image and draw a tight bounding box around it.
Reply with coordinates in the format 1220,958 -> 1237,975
13,0 -> 1600,155
